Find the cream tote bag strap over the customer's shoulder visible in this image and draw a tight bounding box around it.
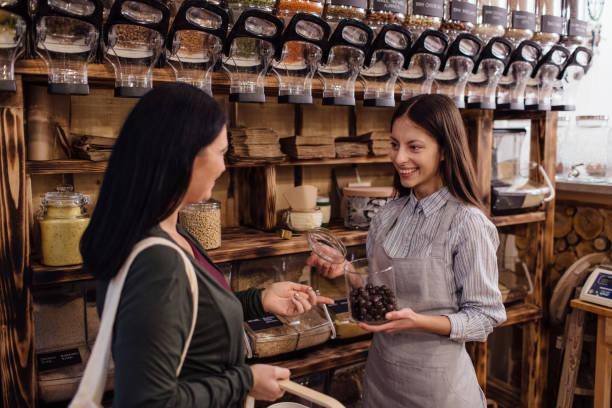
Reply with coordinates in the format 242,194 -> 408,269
70,237 -> 198,408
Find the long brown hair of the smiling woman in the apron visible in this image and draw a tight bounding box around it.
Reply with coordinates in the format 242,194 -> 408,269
391,94 -> 483,209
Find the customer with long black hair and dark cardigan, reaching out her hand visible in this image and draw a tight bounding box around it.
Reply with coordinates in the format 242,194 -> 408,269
81,84 -> 329,408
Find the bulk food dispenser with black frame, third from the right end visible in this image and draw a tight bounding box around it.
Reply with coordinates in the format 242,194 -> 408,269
497,40 -> 542,110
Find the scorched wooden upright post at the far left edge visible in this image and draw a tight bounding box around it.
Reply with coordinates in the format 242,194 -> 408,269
0,78 -> 36,408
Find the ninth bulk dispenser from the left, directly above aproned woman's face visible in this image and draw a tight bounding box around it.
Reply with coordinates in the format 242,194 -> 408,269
399,30 -> 448,101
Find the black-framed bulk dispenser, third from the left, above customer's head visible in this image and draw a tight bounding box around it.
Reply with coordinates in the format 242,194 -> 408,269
103,0 -> 170,98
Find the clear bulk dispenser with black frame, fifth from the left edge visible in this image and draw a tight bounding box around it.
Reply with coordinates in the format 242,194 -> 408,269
223,9 -> 283,102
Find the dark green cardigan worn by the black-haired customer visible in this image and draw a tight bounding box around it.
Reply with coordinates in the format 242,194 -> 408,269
97,227 -> 264,408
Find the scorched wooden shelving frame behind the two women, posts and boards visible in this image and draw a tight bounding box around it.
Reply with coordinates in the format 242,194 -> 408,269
0,65 -> 556,407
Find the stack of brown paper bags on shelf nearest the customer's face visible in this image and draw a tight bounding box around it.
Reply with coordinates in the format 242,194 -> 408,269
228,127 -> 285,163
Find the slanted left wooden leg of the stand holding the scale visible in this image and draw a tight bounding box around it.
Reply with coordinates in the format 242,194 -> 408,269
557,309 -> 585,408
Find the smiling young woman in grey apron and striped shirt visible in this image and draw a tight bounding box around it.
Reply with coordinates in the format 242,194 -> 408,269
309,95 -> 506,408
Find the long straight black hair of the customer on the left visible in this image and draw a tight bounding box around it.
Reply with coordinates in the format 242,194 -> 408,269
81,83 -> 226,280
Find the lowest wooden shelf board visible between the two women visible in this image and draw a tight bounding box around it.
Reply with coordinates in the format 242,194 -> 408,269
273,340 -> 372,377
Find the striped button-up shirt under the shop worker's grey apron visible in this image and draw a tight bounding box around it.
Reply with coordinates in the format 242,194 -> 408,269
366,187 -> 506,342
